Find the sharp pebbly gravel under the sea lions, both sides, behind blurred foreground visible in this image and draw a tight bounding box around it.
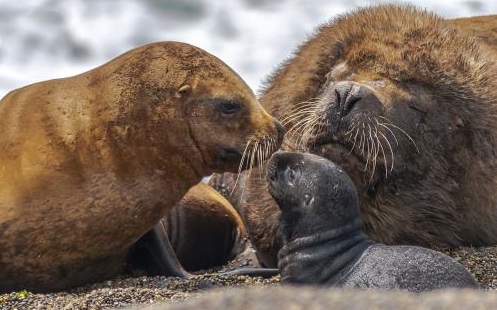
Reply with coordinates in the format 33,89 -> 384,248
0,247 -> 497,310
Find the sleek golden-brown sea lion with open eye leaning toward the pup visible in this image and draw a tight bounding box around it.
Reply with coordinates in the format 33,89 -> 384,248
0,42 -> 283,292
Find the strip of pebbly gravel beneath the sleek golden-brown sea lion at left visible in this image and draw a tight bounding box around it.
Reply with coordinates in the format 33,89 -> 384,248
0,275 -> 278,310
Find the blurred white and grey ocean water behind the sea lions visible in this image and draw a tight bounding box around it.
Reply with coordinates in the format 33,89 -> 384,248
0,0 -> 497,97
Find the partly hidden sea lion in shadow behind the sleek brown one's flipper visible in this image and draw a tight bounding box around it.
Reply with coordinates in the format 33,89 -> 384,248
128,182 -> 248,275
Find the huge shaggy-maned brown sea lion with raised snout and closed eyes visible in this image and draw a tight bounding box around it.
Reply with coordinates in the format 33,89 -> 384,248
214,5 -> 497,266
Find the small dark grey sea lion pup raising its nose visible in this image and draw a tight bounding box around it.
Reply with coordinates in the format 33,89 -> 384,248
267,152 -> 478,292
